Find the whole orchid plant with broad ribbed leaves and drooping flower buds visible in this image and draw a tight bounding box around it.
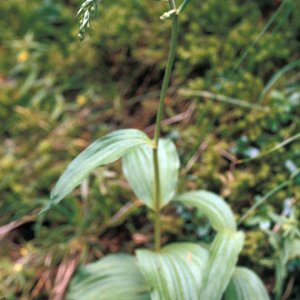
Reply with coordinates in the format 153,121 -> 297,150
48,0 -> 269,300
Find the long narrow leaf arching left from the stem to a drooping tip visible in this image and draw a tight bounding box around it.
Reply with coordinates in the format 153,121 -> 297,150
51,129 -> 151,204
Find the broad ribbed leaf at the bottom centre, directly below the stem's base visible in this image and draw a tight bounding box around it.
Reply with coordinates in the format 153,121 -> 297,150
136,243 -> 209,300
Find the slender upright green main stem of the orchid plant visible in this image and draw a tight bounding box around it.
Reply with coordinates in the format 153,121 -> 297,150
153,0 -> 178,251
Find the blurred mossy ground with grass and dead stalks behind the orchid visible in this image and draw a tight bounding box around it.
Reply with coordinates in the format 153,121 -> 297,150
0,0 -> 300,299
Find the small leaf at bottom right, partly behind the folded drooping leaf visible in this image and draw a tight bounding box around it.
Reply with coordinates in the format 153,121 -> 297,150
225,267 -> 270,300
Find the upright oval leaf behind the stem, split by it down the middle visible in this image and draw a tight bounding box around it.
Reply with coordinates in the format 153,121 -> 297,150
122,139 -> 179,209
